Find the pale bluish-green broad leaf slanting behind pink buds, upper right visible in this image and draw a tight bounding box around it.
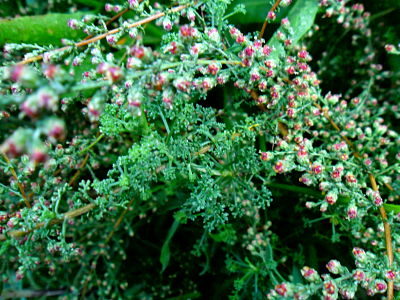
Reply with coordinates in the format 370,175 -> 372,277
268,0 -> 319,59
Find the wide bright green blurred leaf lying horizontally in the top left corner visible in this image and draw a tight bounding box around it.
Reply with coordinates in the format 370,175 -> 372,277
0,12 -> 88,46
